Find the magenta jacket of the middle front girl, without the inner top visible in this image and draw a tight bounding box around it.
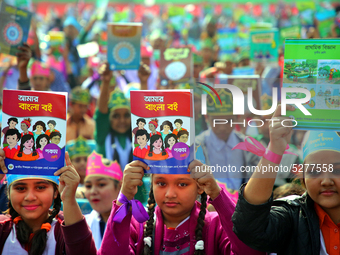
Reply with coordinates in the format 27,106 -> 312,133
97,190 -> 265,255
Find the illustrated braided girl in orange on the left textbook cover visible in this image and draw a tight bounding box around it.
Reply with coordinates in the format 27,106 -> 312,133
13,134 -> 39,161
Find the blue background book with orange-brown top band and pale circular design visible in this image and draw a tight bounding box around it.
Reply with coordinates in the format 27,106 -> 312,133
107,23 -> 142,70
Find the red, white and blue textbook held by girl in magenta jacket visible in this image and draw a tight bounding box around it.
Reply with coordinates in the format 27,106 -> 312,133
130,89 -> 195,174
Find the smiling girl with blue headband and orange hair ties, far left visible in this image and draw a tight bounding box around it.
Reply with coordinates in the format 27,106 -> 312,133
0,150 -> 96,255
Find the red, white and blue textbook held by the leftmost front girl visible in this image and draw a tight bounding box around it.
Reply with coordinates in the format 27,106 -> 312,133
1,90 -> 67,175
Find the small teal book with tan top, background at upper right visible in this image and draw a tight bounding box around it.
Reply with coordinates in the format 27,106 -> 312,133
250,29 -> 279,63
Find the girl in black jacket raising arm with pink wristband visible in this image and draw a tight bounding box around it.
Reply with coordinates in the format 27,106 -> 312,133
233,106 -> 340,255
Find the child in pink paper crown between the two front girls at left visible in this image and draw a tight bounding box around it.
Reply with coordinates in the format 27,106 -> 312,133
85,152 -> 123,249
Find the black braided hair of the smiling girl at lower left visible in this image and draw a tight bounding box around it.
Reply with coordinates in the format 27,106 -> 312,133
7,183 -> 61,255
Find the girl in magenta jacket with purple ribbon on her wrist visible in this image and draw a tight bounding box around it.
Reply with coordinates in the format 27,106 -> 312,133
98,161 -> 264,255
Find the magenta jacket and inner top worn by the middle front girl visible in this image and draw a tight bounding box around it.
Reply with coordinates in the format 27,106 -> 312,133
98,190 -> 264,255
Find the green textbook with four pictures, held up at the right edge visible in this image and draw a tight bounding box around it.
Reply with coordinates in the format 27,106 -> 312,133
282,39 -> 340,131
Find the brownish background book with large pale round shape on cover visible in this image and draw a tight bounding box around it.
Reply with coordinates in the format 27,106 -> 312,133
159,47 -> 193,86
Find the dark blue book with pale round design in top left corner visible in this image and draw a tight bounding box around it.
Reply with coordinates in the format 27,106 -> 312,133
0,1 -> 32,56
